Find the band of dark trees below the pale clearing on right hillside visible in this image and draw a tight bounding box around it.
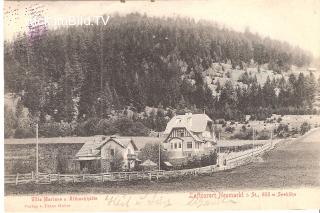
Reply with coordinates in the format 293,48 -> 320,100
207,72 -> 319,120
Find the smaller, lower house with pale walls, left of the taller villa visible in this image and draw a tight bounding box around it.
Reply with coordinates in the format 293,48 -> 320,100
76,136 -> 138,173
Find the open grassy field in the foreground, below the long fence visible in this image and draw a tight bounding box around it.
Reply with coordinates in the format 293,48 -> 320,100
5,130 -> 320,195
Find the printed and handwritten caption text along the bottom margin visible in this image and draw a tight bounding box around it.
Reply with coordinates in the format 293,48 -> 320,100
24,191 -> 297,209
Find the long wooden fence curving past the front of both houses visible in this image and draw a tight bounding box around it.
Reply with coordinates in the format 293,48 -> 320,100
4,141 -> 273,185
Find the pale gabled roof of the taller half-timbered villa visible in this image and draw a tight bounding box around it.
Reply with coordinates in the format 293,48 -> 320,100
164,113 -> 212,134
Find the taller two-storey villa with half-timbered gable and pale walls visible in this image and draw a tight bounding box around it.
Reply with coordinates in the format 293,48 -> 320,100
163,113 -> 216,159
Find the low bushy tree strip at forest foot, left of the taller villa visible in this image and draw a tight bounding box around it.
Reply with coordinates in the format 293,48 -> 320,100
4,105 -> 173,138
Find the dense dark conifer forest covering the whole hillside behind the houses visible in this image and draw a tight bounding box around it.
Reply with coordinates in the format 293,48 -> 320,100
4,14 -> 317,137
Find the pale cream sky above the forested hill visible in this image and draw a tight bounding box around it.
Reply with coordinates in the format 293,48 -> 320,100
4,0 -> 320,57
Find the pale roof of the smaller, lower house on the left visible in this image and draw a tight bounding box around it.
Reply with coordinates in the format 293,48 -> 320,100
76,136 -> 138,158
